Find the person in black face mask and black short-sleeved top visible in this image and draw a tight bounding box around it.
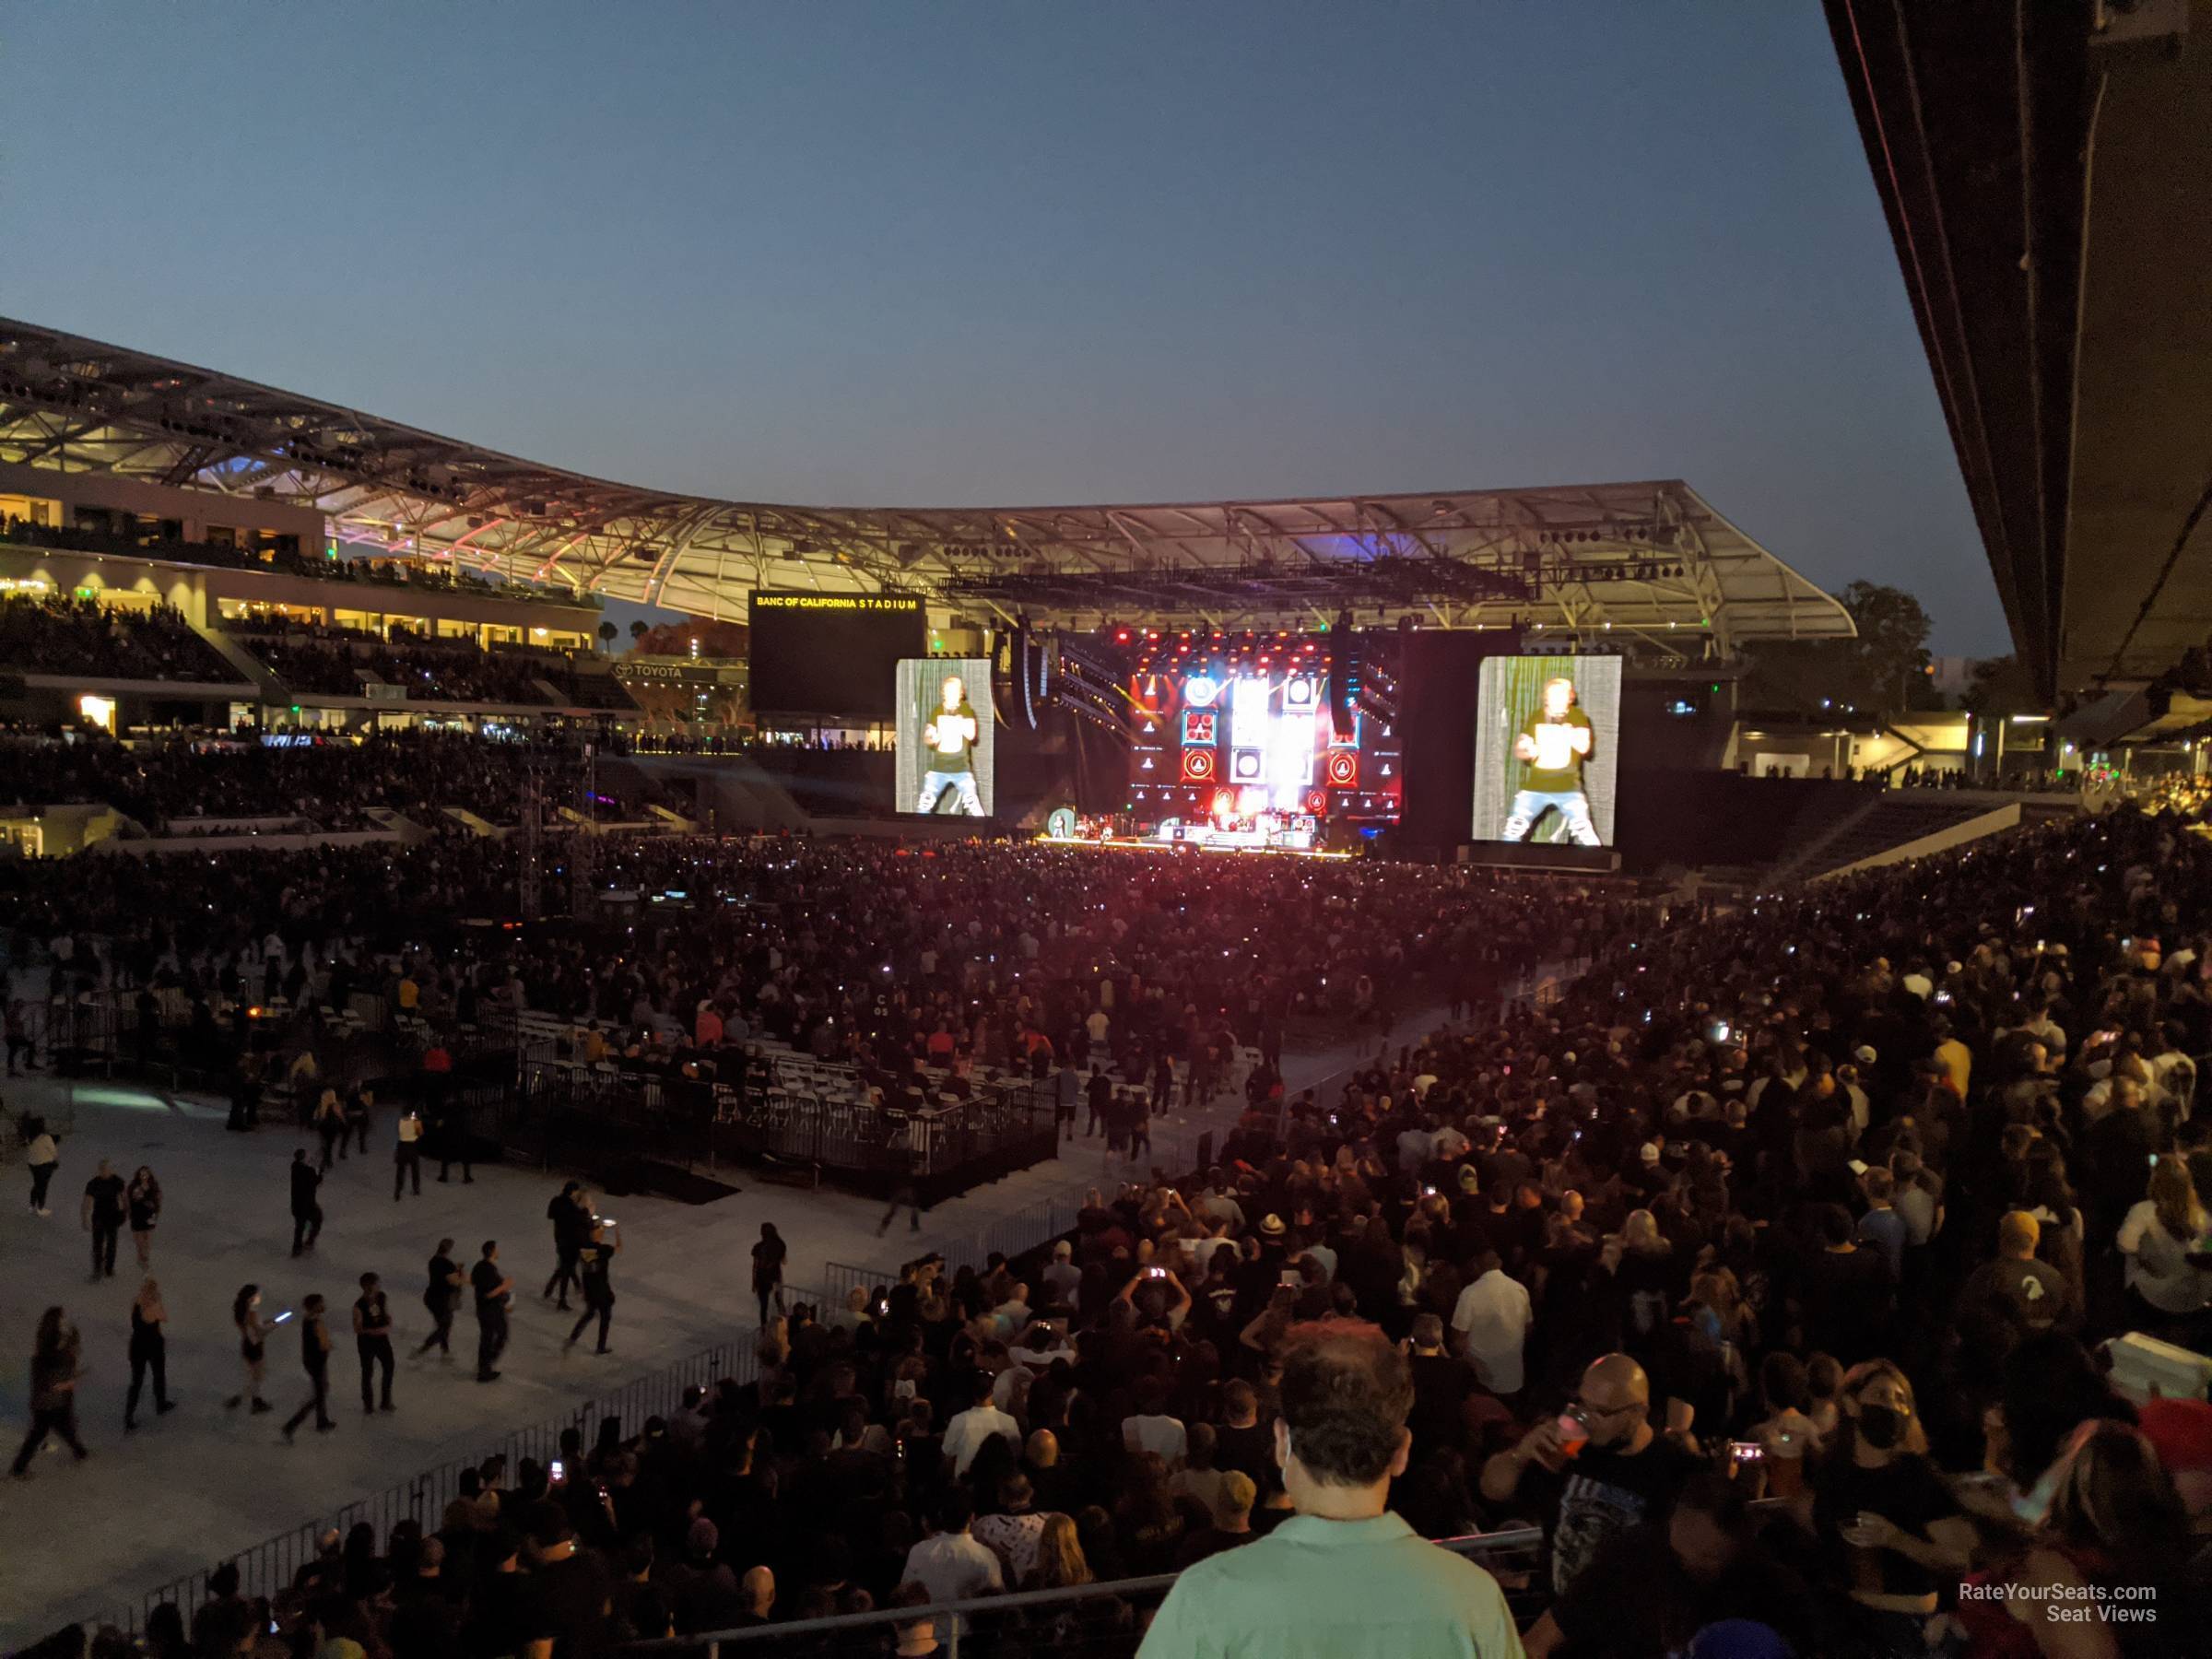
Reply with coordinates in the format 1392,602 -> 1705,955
1812,1360 -> 1973,1653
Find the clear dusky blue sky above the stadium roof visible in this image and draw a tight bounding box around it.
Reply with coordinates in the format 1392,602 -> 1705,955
0,0 -> 2006,654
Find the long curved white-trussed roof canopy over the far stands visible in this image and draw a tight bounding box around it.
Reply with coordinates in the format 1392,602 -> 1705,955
0,319 -> 1852,657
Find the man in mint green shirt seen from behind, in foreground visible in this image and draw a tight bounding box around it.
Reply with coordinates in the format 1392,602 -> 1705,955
1137,1321 -> 1522,1659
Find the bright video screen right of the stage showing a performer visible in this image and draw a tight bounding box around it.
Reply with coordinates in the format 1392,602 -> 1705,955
1473,657 -> 1621,847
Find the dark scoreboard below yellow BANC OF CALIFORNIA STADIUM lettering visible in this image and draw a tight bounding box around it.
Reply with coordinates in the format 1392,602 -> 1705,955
747,591 -> 929,721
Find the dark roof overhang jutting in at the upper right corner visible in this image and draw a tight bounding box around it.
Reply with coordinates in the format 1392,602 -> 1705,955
1825,0 -> 2212,695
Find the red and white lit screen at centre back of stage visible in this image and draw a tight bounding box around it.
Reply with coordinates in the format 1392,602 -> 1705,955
1128,640 -> 1405,847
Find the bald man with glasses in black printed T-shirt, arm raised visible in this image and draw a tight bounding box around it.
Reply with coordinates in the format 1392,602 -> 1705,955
1482,1354 -> 1697,1594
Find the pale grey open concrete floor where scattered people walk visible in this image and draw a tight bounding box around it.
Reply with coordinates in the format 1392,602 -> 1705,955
0,1018 -> 1397,1646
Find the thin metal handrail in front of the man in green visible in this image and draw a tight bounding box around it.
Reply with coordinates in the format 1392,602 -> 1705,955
621,1526 -> 1544,1659
